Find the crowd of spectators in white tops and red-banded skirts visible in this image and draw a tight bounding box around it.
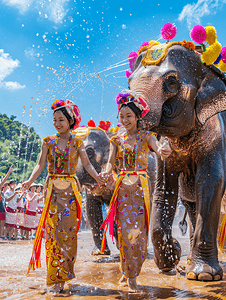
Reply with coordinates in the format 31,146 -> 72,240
0,167 -> 44,240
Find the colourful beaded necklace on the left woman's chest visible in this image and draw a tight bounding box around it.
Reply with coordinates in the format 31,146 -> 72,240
54,133 -> 72,173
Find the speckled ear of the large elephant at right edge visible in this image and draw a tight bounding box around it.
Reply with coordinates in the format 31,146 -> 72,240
195,70 -> 226,125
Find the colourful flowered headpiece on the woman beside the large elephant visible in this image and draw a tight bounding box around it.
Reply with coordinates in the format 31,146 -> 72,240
115,90 -> 149,117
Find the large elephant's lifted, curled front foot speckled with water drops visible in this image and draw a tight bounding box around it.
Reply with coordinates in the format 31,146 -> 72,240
153,238 -> 181,272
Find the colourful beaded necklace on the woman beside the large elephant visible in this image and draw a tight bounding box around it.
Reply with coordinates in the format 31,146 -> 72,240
122,130 -> 140,170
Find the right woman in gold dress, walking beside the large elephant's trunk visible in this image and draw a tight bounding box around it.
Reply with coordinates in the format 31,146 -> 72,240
101,91 -> 171,292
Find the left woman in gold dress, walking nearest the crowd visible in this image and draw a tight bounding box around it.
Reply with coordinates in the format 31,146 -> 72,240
23,99 -> 104,293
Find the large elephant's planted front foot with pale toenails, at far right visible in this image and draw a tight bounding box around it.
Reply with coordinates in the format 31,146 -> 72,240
186,260 -> 223,281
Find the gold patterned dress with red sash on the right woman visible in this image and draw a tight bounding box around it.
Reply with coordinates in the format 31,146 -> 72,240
101,131 -> 154,278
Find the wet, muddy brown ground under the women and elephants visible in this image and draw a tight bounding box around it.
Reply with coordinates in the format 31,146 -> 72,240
0,228 -> 226,300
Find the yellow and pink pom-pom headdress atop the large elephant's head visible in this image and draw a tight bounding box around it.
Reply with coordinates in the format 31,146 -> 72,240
125,23 -> 226,78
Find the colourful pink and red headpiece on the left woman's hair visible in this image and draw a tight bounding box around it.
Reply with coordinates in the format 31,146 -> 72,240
51,99 -> 81,130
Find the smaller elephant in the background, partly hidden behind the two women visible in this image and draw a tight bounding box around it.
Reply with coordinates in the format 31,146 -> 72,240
76,127 -> 156,255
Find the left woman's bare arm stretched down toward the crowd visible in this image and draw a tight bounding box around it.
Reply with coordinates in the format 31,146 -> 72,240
22,142 -> 48,189
